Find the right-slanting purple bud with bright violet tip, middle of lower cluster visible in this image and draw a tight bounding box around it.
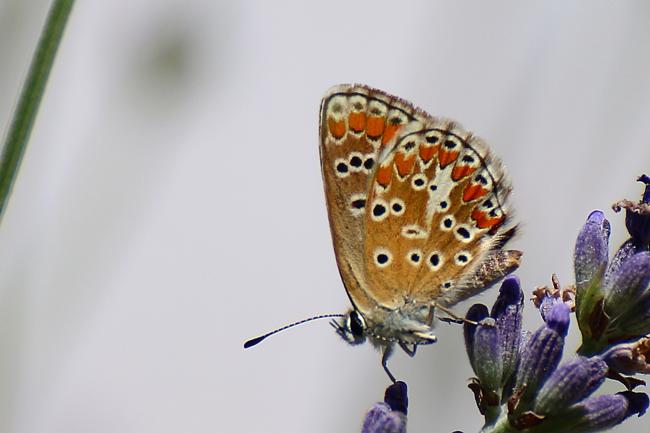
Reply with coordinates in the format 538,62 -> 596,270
515,304 -> 569,402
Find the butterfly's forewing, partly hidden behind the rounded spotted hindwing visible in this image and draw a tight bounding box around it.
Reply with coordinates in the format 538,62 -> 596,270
320,85 -> 422,312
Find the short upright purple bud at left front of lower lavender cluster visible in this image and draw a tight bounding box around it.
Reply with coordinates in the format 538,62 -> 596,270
474,317 -> 503,393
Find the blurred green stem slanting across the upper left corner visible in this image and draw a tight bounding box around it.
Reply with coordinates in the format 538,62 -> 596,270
0,0 -> 74,220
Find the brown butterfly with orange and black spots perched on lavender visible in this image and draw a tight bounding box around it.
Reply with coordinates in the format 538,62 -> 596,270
319,84 -> 521,382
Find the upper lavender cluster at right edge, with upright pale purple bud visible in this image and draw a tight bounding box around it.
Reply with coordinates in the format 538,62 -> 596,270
575,175 -> 650,355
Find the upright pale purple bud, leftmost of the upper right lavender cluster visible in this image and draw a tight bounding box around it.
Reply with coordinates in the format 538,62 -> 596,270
574,211 -> 610,297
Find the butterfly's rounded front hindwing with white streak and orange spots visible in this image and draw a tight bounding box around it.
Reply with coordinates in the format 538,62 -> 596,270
364,111 -> 521,306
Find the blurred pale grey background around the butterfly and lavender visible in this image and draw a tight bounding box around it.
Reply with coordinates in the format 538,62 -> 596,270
0,0 -> 650,433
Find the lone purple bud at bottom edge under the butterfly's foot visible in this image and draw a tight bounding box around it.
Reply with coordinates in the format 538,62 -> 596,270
361,381 -> 408,433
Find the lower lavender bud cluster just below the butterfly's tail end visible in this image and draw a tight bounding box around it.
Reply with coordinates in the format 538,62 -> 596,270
464,276 -> 650,433
